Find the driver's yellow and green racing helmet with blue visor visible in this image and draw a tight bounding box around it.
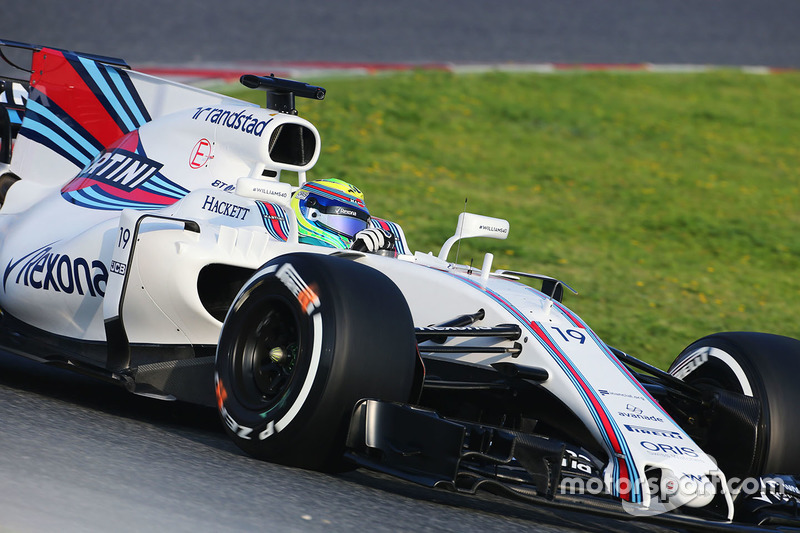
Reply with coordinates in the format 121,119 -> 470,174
291,178 -> 369,248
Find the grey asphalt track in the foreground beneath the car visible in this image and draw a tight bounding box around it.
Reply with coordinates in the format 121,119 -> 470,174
0,355 -> 688,533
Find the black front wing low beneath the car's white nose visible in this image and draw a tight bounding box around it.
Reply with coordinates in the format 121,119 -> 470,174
346,399 -> 800,531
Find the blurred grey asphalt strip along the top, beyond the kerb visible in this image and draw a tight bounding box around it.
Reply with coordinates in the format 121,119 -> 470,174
0,0 -> 800,67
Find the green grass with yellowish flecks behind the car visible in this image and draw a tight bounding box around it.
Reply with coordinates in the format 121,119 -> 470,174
223,71 -> 800,367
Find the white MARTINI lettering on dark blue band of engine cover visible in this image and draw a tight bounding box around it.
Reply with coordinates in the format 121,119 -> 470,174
77,148 -> 164,192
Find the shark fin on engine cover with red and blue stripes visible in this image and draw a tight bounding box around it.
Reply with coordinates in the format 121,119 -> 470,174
0,39 -> 250,193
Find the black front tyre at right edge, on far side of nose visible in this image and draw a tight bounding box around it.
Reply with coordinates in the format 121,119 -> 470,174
669,332 -> 800,478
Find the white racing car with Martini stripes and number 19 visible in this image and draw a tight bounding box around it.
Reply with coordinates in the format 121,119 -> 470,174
0,41 -> 800,527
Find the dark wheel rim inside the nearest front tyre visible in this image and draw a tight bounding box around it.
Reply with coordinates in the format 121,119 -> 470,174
232,300 -> 300,414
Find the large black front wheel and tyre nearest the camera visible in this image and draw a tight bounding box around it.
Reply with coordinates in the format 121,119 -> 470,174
215,253 -> 417,470
